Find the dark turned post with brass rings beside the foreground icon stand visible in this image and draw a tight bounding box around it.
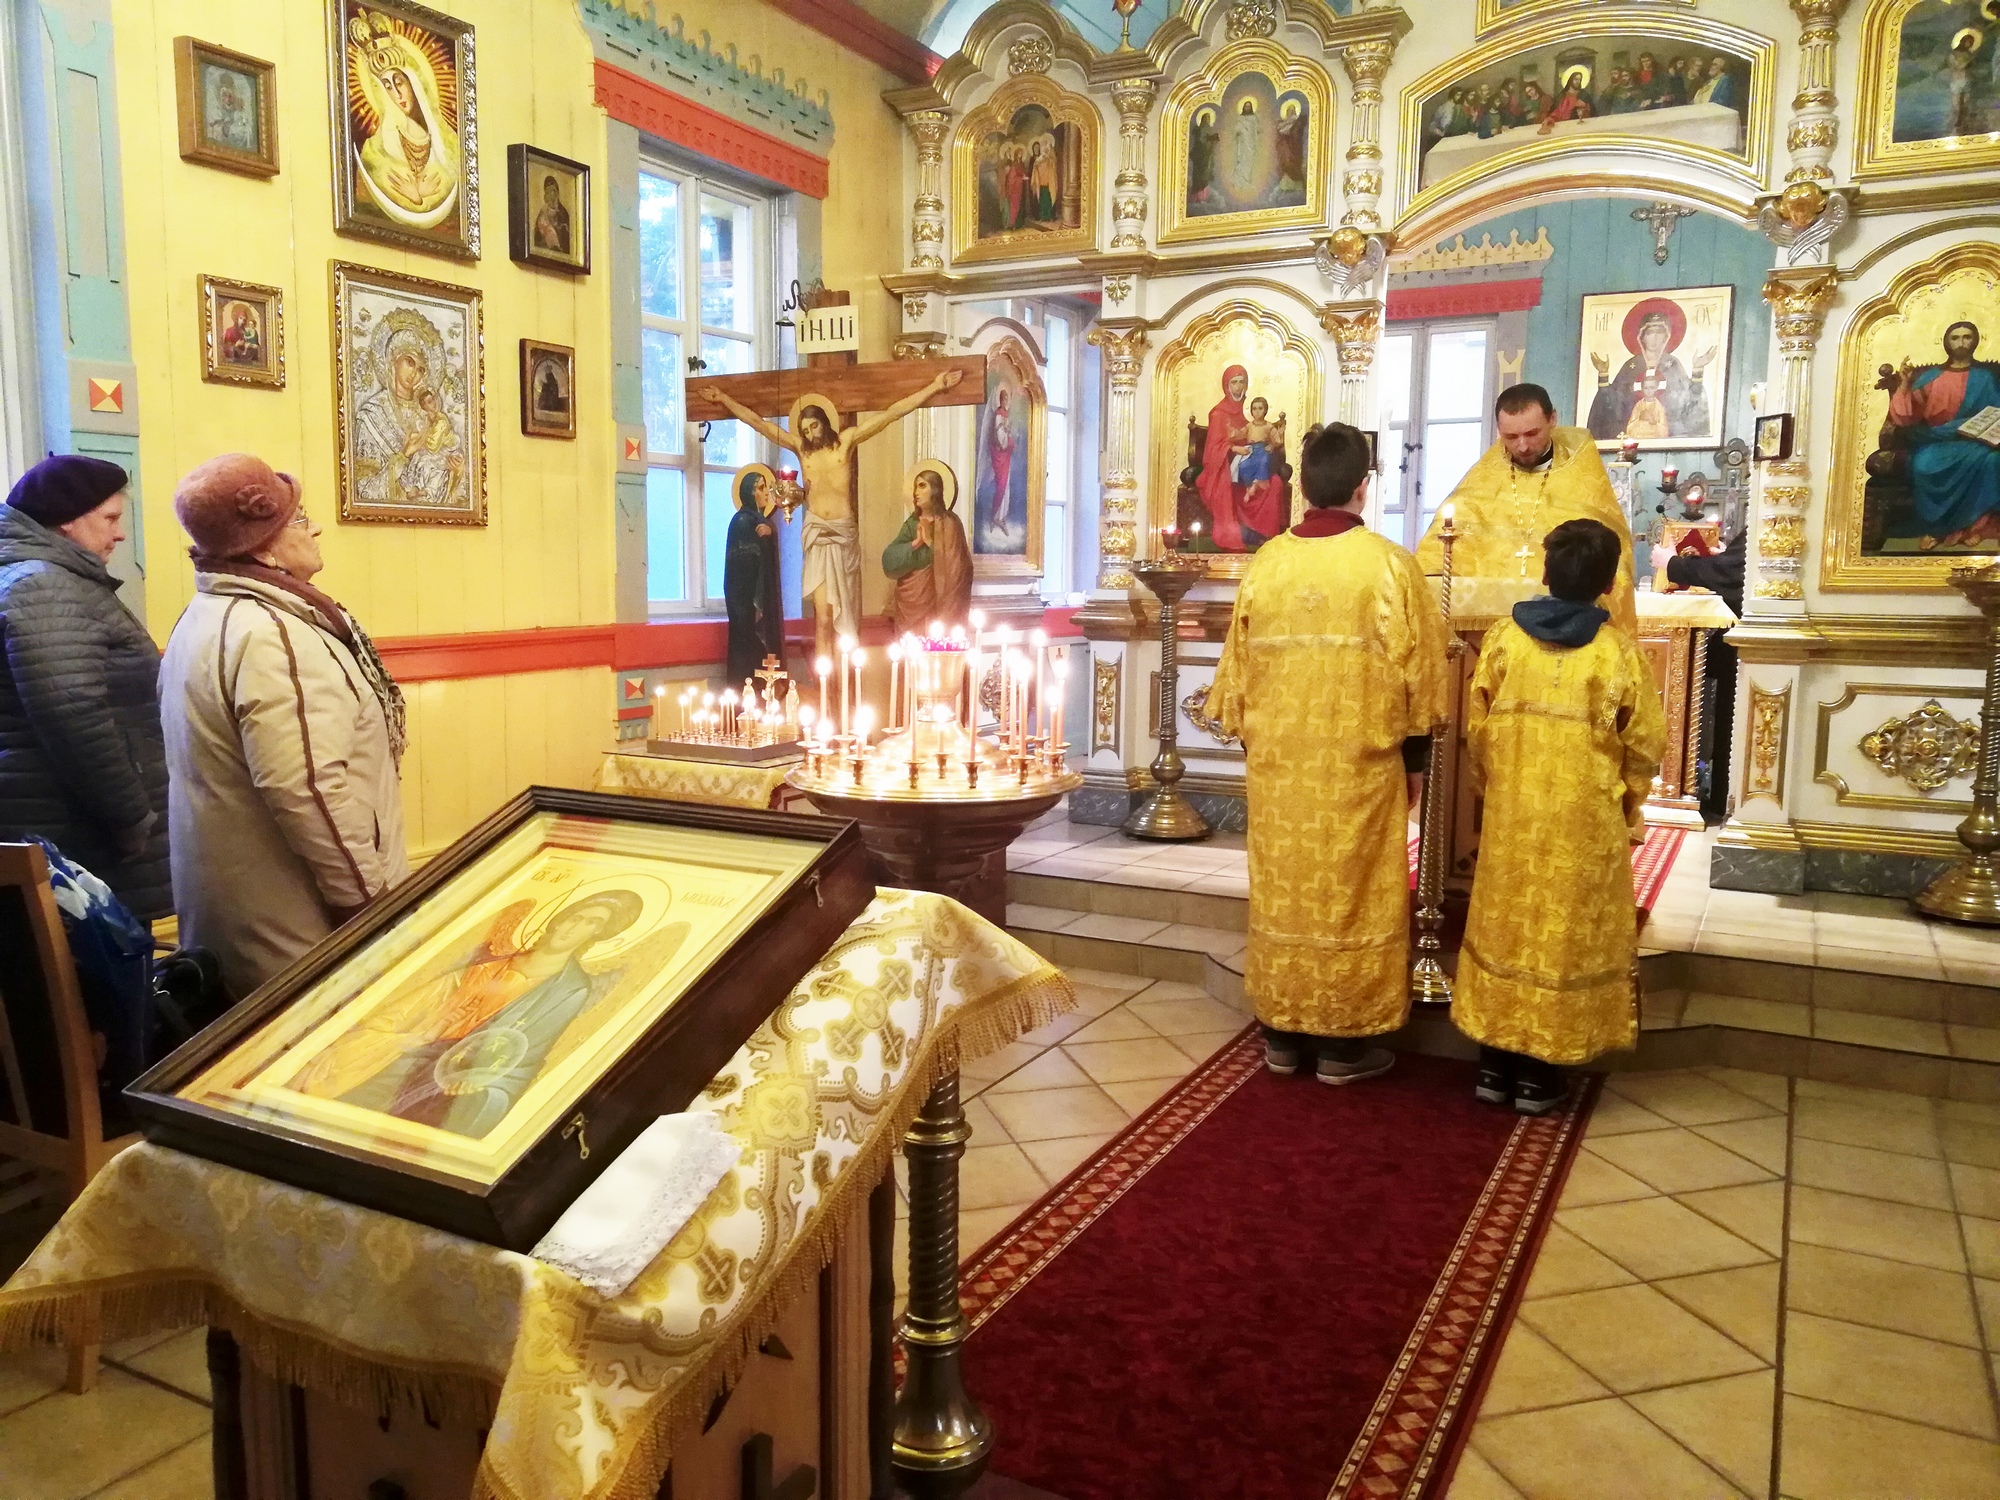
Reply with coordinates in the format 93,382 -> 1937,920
894,1072 -> 994,1500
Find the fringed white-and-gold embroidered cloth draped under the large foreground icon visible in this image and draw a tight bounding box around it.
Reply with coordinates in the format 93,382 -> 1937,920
0,890 -> 1074,1500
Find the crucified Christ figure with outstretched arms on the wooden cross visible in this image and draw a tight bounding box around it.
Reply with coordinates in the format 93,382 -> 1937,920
696,370 -> 964,656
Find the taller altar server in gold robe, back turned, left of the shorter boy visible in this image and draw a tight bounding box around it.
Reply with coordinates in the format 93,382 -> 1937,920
1208,422 -> 1444,1084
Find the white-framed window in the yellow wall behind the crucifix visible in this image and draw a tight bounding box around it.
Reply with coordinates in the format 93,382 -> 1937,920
638,158 -> 772,614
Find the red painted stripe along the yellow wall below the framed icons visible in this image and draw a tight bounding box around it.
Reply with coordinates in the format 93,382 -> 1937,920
376,608 -> 1084,682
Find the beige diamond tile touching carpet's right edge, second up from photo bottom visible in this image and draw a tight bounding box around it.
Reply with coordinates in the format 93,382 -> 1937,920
1520,1286 -> 1762,1396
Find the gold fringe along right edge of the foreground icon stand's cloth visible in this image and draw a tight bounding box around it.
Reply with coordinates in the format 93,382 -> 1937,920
472,964 -> 1076,1500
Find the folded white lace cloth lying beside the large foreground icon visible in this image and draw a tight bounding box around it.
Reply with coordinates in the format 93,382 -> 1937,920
530,1110 -> 744,1296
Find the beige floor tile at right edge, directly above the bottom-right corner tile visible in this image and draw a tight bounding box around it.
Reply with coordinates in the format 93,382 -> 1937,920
1784,1312 -> 2000,1440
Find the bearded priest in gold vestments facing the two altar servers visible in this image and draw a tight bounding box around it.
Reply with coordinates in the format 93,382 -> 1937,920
1416,386 -> 1638,640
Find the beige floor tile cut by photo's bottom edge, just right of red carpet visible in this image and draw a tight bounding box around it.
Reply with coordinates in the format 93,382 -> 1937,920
1478,1398 -> 1742,1500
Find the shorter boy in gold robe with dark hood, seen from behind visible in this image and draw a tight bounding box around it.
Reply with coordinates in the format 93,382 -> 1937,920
1452,520 -> 1666,1114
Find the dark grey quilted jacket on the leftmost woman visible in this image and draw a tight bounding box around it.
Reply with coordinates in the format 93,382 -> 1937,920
0,504 -> 174,920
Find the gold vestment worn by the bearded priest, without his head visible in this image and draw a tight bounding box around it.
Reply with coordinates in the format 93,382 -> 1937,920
1416,428 -> 1638,640
